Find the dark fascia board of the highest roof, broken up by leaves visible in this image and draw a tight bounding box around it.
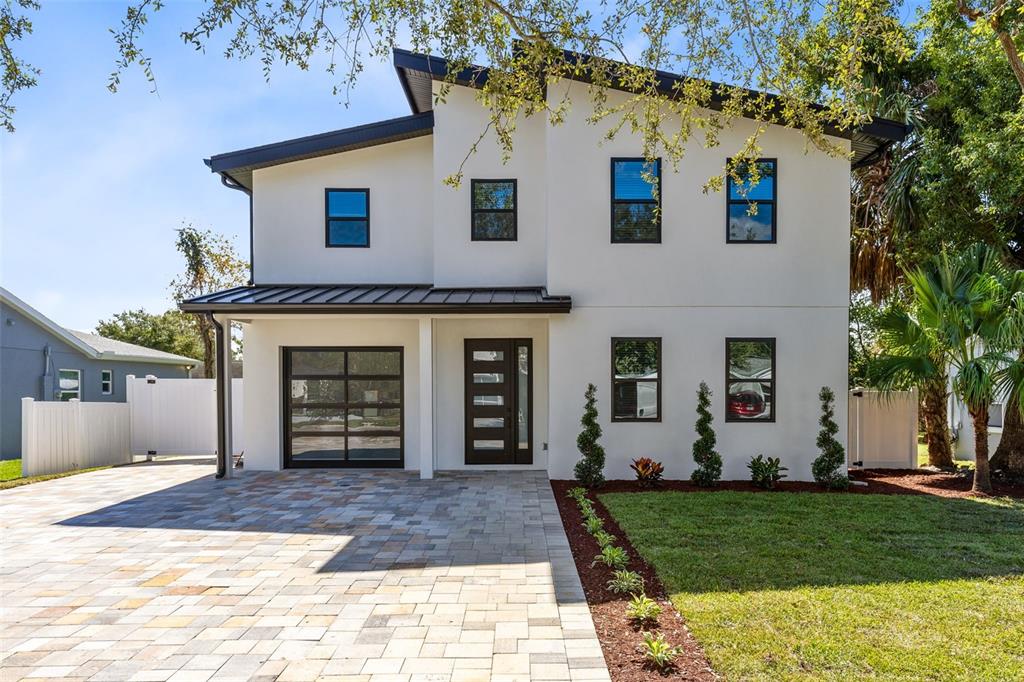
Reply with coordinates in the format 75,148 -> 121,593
393,48 -> 907,141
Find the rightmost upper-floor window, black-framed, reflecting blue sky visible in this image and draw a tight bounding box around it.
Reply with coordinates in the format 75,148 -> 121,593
726,159 -> 777,244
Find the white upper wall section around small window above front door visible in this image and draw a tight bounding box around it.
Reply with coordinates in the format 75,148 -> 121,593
433,83 -> 547,287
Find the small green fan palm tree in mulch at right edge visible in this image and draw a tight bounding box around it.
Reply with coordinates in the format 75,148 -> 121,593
871,244 -> 1024,493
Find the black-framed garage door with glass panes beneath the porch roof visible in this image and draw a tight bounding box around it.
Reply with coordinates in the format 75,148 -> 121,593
284,347 -> 403,468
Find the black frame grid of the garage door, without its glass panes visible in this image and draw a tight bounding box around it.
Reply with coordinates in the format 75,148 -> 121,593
281,345 -> 406,469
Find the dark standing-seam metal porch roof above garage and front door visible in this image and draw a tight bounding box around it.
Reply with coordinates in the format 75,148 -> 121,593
179,284 -> 572,314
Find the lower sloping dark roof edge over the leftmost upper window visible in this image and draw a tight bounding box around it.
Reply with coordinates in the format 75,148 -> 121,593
206,111 -> 434,189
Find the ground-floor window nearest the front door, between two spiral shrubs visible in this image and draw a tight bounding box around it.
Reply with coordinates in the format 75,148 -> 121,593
611,338 -> 662,422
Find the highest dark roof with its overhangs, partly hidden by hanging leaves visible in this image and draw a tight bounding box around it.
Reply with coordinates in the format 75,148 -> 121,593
393,48 -> 907,167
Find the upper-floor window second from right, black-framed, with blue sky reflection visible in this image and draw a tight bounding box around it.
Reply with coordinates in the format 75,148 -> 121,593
611,159 -> 662,244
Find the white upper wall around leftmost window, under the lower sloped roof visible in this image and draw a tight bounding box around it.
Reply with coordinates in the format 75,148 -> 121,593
253,135 -> 433,284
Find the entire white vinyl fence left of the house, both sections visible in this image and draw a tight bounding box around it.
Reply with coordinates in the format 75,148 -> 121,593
22,375 -> 243,476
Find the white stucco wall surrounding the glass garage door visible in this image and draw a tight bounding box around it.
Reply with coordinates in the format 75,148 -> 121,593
243,315 -> 420,471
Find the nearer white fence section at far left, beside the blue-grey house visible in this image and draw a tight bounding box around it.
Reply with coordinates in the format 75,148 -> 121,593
22,397 -> 132,476
